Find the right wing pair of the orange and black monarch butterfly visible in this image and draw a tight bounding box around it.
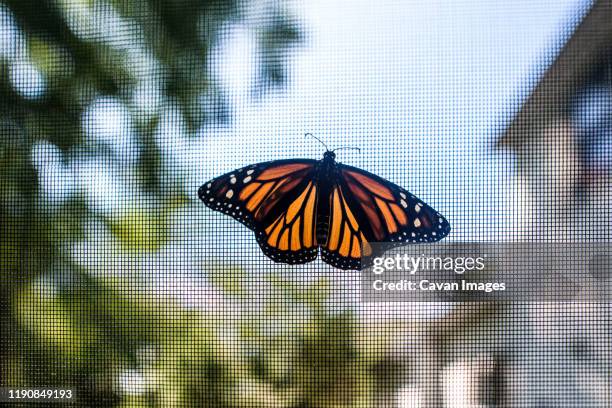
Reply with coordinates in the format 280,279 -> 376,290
321,164 -> 450,269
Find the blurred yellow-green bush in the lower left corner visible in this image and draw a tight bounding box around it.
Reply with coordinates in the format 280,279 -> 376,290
13,273 -> 239,406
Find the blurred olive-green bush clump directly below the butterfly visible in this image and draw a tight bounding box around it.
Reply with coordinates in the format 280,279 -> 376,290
243,275 -> 372,407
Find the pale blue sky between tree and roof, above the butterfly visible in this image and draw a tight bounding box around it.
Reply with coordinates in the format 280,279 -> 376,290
186,0 -> 590,240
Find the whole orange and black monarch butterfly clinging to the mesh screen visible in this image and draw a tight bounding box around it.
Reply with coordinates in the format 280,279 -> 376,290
198,136 -> 450,270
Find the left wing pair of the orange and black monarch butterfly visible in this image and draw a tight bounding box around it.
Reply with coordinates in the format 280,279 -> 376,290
198,159 -> 318,264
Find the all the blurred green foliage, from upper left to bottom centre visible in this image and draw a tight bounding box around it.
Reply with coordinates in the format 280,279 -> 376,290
0,0 -> 392,408
